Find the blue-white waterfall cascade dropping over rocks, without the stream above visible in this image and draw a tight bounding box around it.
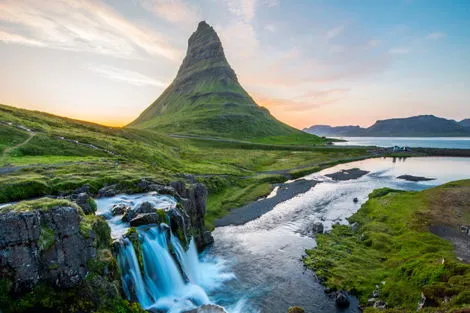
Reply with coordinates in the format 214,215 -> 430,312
118,224 -> 210,313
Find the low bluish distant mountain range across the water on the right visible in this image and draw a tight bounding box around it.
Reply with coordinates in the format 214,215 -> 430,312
303,115 -> 470,137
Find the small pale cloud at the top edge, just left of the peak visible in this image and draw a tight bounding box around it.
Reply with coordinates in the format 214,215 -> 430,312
139,0 -> 201,25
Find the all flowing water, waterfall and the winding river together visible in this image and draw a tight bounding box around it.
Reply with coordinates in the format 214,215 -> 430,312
94,157 -> 470,313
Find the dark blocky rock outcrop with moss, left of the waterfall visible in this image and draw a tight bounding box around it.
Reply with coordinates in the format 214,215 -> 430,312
0,205 -> 97,293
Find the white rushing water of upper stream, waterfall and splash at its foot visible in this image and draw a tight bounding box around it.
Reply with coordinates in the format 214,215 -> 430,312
97,193 -> 246,313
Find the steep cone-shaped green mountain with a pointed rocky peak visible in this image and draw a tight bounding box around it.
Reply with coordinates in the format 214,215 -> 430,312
127,21 -> 319,140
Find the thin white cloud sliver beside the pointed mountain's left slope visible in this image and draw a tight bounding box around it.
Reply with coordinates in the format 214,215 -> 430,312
87,65 -> 167,87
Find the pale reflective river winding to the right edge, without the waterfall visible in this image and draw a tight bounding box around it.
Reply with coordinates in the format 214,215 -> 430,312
211,157 -> 470,313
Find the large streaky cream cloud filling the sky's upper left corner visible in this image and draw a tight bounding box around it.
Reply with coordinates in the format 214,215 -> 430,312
0,0 -> 180,60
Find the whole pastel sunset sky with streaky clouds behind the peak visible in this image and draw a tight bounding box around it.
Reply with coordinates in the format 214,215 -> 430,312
0,0 -> 470,128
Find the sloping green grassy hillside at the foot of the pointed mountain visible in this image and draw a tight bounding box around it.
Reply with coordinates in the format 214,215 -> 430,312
0,105 -> 369,223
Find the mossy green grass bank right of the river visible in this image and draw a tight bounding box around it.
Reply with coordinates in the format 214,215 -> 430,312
304,180 -> 470,312
